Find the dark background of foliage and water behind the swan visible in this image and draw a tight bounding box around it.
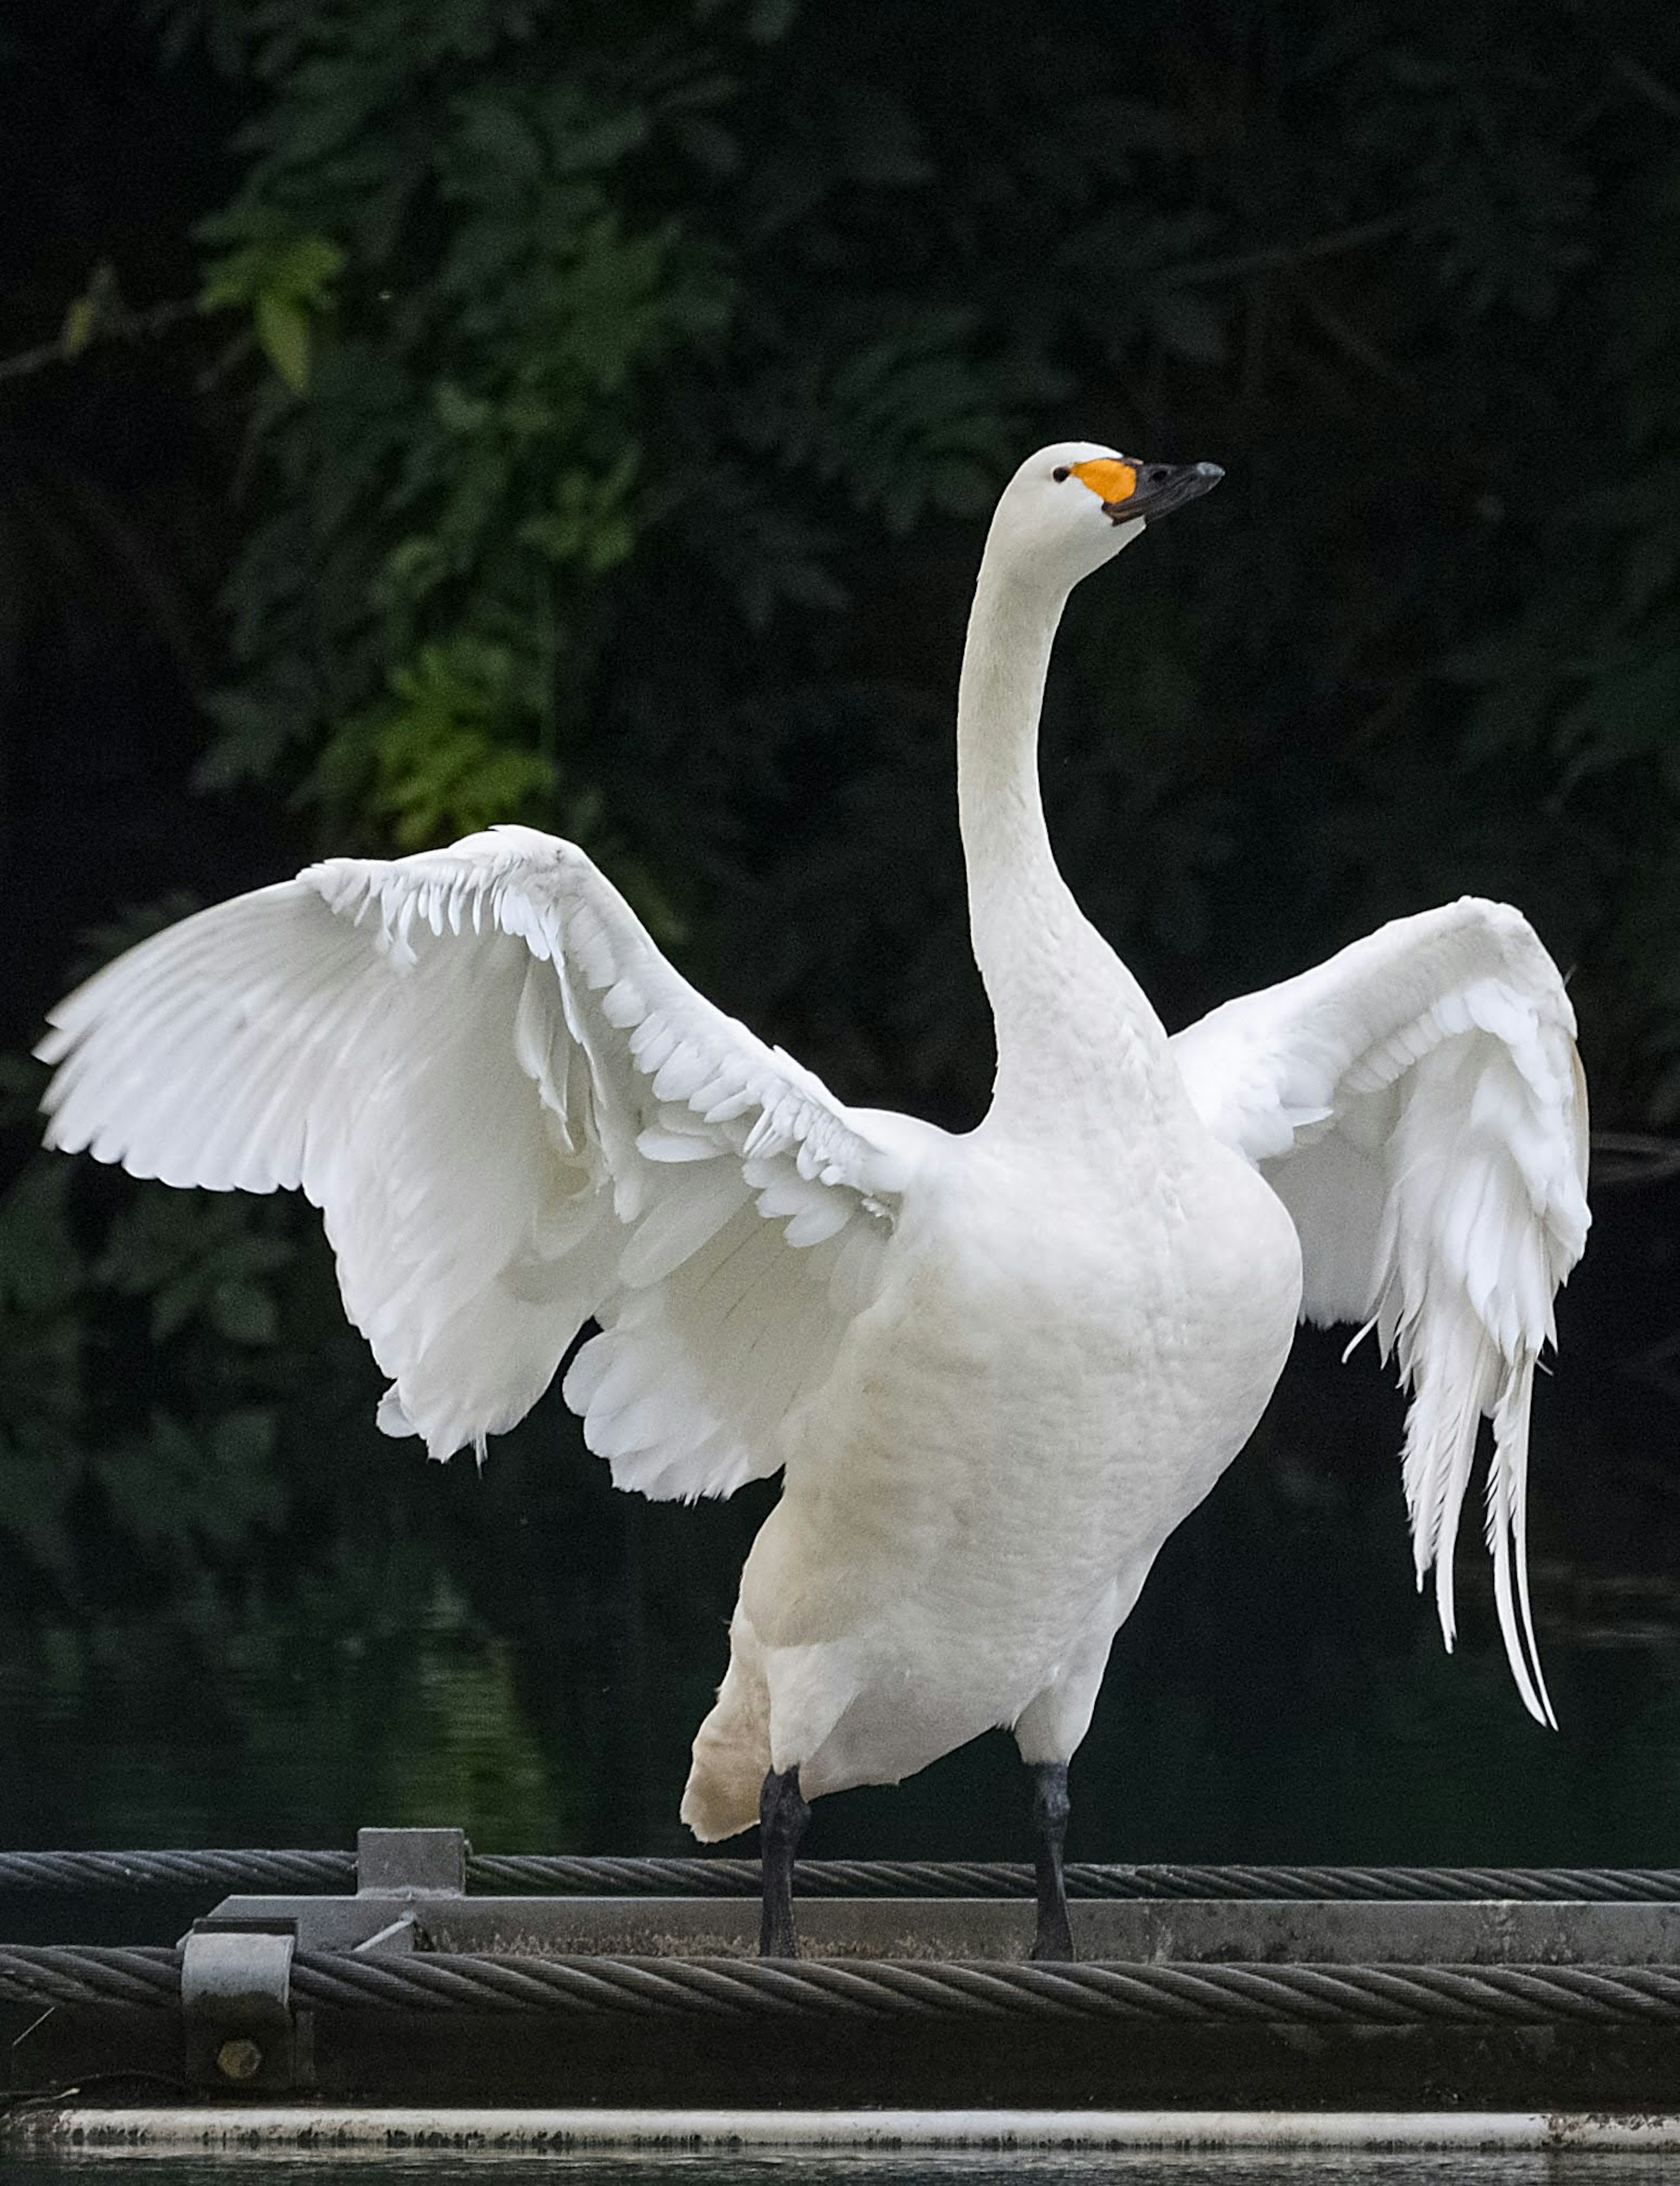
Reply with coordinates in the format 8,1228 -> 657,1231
0,0 -> 1680,1862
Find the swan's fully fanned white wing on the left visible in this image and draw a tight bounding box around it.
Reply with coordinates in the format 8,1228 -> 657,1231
39,829 -> 936,1497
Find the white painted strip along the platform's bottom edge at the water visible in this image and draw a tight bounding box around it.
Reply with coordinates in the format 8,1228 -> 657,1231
0,2103 -> 1680,2155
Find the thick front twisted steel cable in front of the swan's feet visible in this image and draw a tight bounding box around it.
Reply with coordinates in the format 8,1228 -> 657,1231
0,1945 -> 1680,2026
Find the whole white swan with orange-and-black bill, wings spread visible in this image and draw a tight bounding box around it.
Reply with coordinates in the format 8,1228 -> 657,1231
42,444 -> 1588,1956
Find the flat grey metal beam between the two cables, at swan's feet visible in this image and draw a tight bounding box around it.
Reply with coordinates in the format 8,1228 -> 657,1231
200,1891 -> 1680,1965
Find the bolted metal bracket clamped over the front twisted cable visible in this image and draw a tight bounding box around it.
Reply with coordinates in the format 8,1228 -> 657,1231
182,1917 -> 313,2094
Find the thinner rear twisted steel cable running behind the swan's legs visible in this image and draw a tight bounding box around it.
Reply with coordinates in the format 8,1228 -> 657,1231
0,1849 -> 1680,1904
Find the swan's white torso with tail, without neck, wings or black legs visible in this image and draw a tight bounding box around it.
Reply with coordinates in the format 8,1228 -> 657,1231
682,1112 -> 1302,1836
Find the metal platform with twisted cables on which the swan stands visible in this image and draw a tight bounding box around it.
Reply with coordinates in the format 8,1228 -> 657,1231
0,1829 -> 1680,2147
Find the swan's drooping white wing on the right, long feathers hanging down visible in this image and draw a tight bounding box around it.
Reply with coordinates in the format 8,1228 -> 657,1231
1172,896 -> 1588,1723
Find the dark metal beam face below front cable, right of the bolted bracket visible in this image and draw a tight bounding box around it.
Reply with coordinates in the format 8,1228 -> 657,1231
147,2009 -> 1676,2112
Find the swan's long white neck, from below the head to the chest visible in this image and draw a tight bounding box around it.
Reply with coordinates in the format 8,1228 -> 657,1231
956,555 -> 1181,1132
